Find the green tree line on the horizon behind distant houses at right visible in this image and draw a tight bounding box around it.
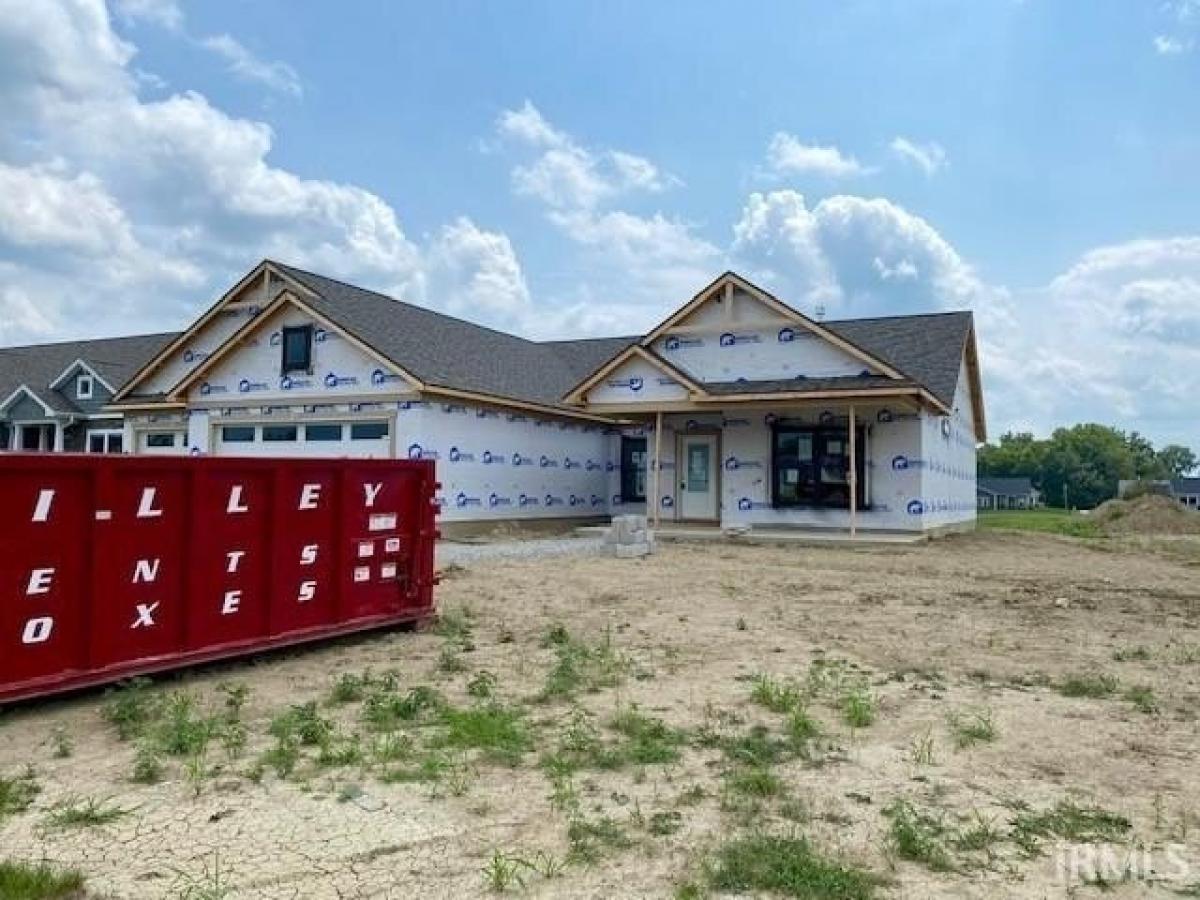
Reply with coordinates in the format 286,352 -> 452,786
979,424 -> 1198,509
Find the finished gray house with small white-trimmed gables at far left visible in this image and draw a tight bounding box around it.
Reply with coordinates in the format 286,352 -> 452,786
0,335 -> 174,452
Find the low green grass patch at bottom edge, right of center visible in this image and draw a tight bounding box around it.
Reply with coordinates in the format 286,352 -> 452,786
691,835 -> 878,900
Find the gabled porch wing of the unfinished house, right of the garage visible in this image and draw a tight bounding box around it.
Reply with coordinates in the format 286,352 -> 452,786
566,272 -> 985,532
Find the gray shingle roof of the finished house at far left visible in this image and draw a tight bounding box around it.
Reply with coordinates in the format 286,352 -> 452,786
0,334 -> 175,415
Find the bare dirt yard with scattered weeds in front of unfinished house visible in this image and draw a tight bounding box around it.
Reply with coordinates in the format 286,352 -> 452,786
0,533 -> 1200,899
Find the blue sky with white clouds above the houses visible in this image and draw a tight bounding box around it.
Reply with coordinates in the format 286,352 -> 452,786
0,0 -> 1200,446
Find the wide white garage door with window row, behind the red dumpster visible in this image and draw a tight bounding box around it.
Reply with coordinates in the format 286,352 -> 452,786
212,420 -> 392,460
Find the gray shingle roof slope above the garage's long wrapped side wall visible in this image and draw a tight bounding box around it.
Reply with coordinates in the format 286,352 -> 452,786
272,263 -> 637,406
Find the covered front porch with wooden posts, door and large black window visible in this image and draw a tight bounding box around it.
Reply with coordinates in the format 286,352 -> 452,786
614,396 -> 950,542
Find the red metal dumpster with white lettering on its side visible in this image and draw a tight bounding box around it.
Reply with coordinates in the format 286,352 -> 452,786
0,455 -> 437,701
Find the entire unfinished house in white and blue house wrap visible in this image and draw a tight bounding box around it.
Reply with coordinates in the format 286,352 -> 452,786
0,260 -> 985,540
